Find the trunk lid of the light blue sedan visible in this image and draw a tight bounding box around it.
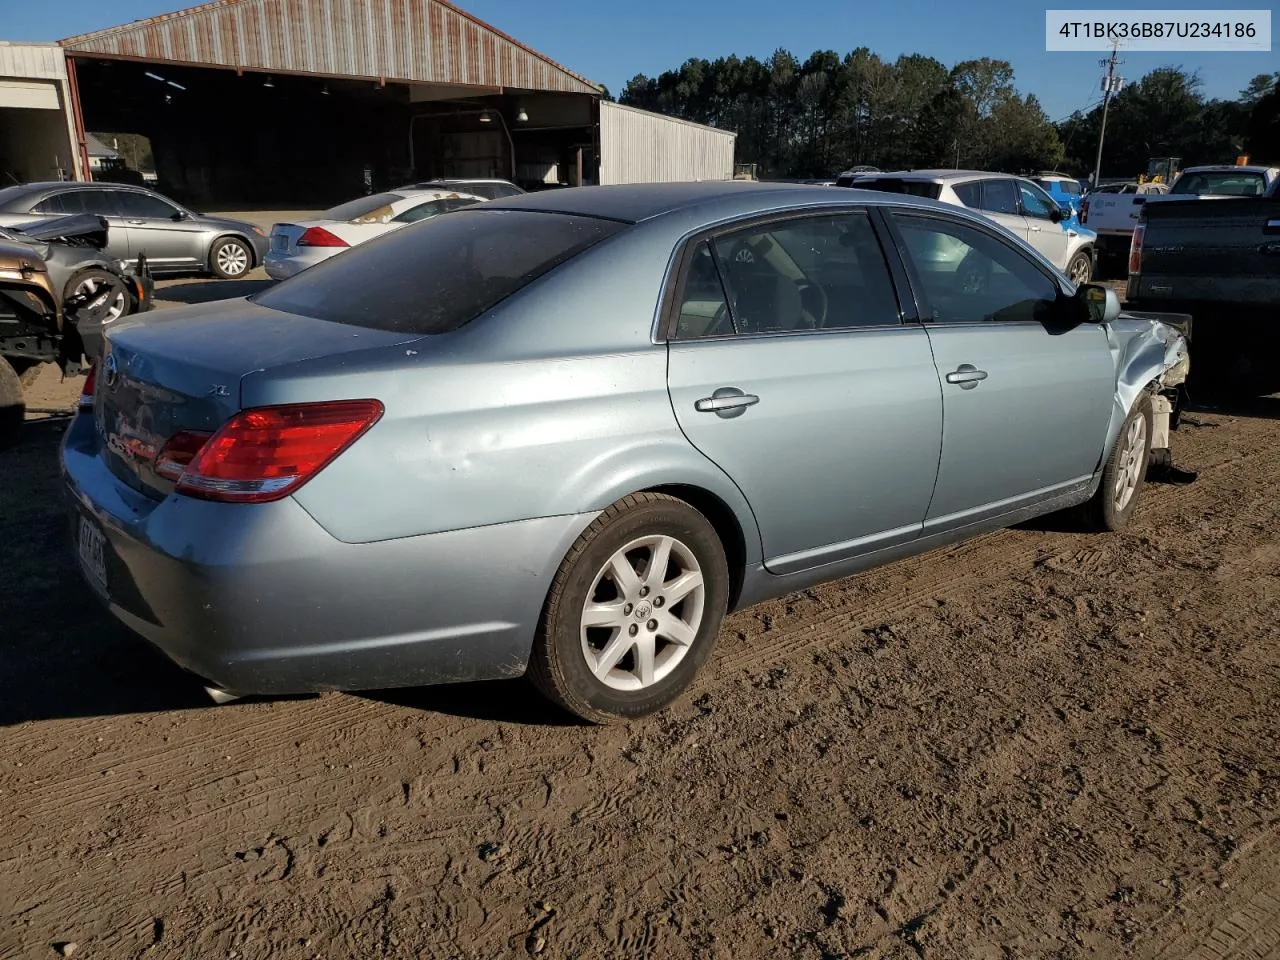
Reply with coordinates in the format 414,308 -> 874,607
93,301 -> 416,498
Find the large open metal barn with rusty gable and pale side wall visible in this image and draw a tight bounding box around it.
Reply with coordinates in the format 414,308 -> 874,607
0,0 -> 733,210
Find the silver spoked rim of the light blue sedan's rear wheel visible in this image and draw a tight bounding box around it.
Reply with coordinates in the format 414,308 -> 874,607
580,535 -> 707,690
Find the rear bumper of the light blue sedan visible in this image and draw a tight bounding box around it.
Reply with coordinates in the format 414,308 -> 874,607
61,415 -> 591,695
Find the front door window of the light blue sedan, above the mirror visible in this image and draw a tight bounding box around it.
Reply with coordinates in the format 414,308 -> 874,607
893,212 -> 1059,324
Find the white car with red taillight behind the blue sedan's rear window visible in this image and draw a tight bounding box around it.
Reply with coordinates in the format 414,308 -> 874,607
262,187 -> 485,280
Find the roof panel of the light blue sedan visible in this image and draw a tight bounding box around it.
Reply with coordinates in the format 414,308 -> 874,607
484,180 -> 960,224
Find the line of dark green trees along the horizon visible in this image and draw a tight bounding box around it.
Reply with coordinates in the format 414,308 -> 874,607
618,47 -> 1280,178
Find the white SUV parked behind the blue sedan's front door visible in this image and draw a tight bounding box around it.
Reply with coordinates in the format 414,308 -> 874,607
841,170 -> 1097,287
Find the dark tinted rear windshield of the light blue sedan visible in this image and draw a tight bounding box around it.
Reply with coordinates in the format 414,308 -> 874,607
253,209 -> 626,335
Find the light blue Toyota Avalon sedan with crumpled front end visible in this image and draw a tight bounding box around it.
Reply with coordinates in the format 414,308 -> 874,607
61,183 -> 1188,722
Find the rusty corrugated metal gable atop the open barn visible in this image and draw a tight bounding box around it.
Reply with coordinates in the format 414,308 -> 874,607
60,0 -> 599,93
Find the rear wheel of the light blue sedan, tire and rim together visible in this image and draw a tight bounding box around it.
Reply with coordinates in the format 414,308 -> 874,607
529,493 -> 730,723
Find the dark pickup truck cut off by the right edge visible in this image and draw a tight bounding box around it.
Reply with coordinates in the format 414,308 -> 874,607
1125,179 -> 1280,397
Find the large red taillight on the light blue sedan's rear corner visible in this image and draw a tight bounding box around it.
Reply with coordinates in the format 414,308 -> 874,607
175,399 -> 383,503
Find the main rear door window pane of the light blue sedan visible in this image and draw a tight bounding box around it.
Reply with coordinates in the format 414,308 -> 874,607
691,212 -> 900,334
